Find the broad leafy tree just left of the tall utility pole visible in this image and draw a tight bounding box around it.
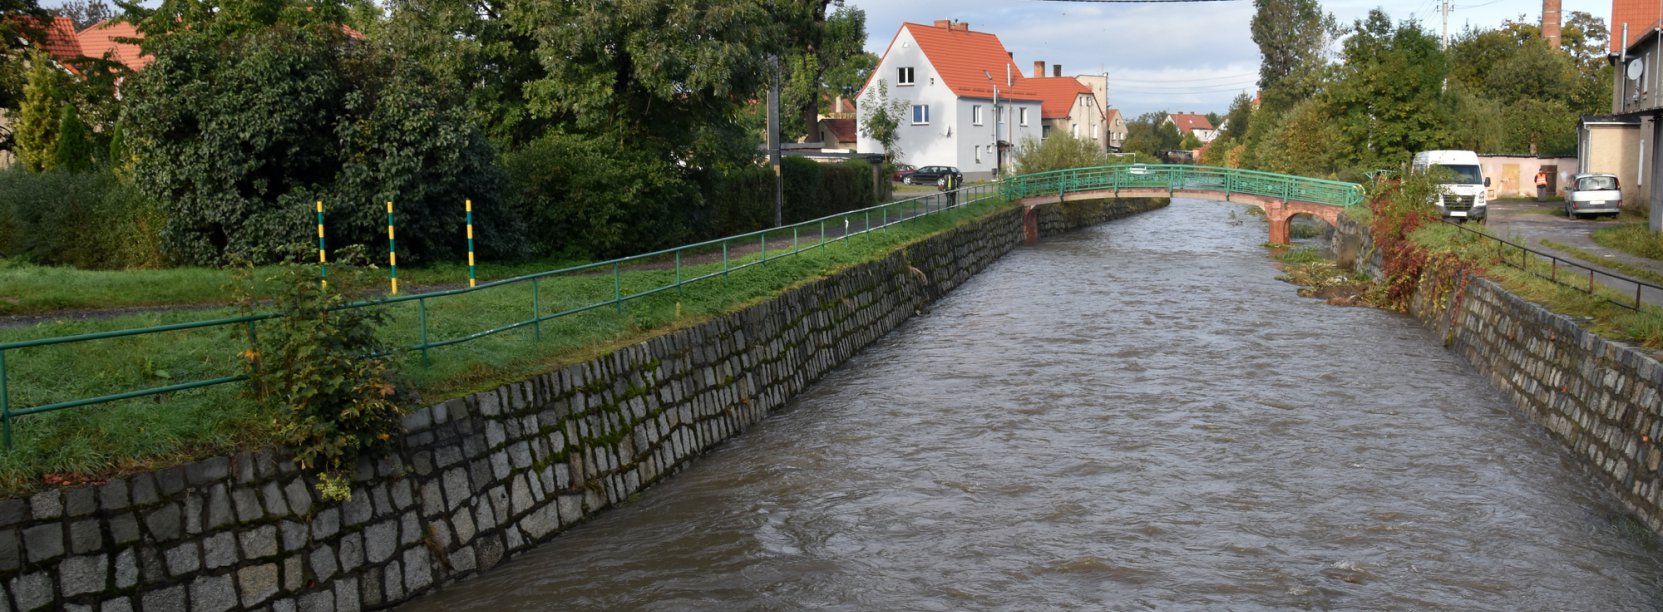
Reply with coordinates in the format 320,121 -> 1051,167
507,0 -> 780,168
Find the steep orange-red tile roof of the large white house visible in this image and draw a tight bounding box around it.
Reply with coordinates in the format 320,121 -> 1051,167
856,22 -> 1039,101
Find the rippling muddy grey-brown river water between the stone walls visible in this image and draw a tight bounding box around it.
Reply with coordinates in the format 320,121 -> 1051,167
404,201 -> 1663,612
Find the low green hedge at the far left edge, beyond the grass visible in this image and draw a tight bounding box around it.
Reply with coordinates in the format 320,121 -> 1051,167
0,166 -> 165,269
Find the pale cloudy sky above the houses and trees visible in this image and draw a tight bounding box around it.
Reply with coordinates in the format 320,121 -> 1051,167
846,0 -> 1611,118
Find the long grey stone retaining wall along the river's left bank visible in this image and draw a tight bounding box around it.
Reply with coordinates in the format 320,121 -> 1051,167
0,201 -> 1162,612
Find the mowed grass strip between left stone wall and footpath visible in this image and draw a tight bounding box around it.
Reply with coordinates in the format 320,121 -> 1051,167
0,200 -> 1003,494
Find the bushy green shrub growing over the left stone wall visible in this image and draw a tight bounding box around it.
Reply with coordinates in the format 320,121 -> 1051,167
243,248 -> 407,501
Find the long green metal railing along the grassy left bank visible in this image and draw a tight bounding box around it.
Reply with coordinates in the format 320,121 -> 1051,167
0,185 -> 999,449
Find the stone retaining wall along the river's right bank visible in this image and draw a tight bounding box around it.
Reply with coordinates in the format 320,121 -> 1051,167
1332,214 -> 1663,532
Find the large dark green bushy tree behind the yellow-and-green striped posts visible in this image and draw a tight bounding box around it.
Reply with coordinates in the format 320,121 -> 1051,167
123,0 -> 502,264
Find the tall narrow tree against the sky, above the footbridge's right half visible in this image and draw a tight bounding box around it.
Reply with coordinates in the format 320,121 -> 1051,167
1249,0 -> 1339,111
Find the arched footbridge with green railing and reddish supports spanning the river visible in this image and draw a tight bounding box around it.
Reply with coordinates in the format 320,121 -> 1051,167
1001,165 -> 1364,244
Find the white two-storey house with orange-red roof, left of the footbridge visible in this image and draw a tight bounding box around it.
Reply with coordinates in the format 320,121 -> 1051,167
855,20 -> 1037,175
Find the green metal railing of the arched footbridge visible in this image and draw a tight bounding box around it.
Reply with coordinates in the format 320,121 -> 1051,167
1001,163 -> 1364,208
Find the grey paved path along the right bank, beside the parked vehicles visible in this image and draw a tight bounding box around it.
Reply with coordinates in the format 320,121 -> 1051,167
1488,200 -> 1663,306
